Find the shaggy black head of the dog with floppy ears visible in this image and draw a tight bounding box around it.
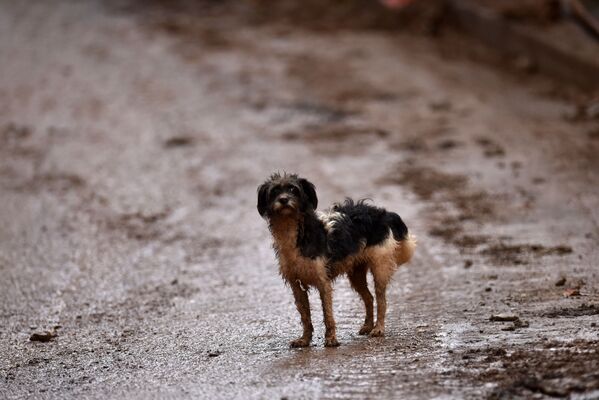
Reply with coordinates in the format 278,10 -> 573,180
258,173 -> 318,218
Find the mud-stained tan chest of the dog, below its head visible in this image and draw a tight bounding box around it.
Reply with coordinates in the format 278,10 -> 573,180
271,220 -> 326,285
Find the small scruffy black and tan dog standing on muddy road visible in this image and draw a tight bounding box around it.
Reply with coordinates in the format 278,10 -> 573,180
257,173 -> 416,347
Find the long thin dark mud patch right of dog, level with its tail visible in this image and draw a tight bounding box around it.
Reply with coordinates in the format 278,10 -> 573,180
480,243 -> 572,265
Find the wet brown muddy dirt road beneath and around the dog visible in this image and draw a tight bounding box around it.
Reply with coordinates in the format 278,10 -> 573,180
0,1 -> 599,399
